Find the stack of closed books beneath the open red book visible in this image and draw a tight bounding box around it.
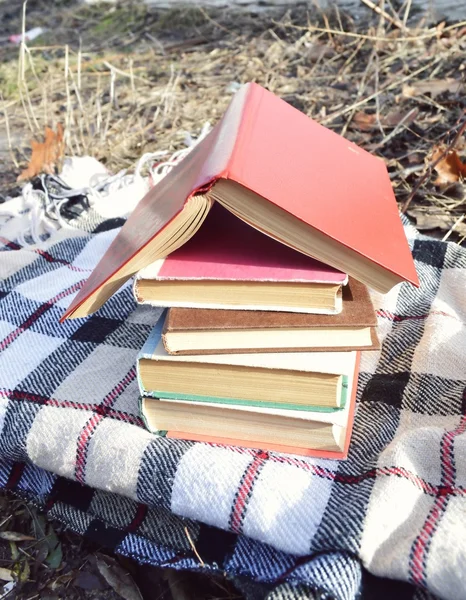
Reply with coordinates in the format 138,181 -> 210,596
134,205 -> 378,455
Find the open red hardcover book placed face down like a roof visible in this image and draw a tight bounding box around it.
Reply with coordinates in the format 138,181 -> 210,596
63,83 -> 419,318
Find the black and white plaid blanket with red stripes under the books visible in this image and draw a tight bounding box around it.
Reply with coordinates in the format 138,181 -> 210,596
0,178 -> 466,600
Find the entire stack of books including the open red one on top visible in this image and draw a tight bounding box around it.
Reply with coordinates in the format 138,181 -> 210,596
65,84 -> 418,458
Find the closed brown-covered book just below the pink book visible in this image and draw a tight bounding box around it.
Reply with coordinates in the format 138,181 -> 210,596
162,278 -> 380,355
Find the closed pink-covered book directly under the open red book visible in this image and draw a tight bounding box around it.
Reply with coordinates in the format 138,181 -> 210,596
134,204 -> 348,314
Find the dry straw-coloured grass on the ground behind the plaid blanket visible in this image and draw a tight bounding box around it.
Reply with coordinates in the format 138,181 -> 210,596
0,3 -> 466,239
